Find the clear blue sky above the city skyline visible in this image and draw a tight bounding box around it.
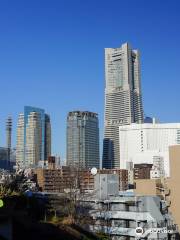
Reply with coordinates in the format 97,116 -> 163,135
0,0 -> 180,161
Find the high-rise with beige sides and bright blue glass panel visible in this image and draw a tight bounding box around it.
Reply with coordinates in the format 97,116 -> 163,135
16,106 -> 51,168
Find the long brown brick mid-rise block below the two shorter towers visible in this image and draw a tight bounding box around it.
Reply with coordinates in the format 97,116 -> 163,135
35,167 -> 128,193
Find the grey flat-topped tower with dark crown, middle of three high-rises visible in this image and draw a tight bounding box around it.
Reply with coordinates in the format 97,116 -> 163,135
66,111 -> 100,169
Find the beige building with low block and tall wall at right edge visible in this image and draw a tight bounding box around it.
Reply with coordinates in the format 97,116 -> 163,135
134,145 -> 180,230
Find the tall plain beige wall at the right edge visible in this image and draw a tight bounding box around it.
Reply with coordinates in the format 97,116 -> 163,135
167,145 -> 180,229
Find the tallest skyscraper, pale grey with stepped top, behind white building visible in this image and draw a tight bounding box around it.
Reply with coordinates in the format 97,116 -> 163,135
103,43 -> 143,168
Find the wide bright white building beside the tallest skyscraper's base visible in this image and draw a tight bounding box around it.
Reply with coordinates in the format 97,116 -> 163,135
119,122 -> 180,176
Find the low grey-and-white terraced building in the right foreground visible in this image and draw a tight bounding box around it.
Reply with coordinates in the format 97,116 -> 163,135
77,193 -> 179,240
